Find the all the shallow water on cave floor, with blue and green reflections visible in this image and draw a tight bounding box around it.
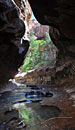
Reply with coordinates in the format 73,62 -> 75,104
0,85 -> 61,130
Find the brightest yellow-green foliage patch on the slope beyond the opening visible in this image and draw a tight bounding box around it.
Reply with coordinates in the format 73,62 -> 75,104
21,40 -> 45,72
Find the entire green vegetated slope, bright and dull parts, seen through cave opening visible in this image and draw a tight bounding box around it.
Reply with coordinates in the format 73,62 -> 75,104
21,32 -> 56,72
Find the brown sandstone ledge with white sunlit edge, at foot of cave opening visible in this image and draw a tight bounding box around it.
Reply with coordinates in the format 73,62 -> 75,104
15,67 -> 55,85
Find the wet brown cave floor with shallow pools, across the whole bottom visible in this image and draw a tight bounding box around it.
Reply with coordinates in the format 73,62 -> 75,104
0,83 -> 75,130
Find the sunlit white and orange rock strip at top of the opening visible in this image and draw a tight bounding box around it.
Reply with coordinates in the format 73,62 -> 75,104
14,0 -> 32,40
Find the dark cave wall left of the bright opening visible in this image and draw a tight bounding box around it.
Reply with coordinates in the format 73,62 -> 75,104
0,0 -> 29,83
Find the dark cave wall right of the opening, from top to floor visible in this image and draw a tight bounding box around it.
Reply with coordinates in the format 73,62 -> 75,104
29,0 -> 75,85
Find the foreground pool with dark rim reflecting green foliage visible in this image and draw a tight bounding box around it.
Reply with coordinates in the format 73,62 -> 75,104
15,103 -> 61,130
